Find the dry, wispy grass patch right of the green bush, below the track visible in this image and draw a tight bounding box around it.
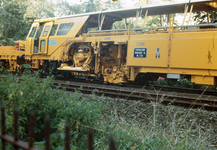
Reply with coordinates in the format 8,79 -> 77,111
86,89 -> 217,150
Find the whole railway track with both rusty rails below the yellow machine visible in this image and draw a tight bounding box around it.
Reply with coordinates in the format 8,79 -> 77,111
1,77 -> 217,111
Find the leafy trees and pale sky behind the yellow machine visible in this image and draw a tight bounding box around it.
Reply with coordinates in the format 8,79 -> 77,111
0,0 -> 181,46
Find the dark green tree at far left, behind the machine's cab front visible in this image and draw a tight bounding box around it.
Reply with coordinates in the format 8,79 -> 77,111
0,0 -> 30,45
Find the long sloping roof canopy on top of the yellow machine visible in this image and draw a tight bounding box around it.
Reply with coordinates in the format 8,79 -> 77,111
35,0 -> 217,21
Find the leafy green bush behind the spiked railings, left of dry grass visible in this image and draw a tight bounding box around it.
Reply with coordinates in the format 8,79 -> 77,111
0,75 -> 102,149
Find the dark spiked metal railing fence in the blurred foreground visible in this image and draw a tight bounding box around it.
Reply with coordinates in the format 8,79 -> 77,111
0,104 -> 116,150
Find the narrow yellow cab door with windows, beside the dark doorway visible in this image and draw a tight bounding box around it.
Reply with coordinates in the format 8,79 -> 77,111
39,22 -> 53,54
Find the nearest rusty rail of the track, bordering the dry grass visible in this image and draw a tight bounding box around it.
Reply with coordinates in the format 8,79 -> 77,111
53,80 -> 217,111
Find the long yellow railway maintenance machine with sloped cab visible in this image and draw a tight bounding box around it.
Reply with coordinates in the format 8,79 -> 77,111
0,0 -> 217,85
